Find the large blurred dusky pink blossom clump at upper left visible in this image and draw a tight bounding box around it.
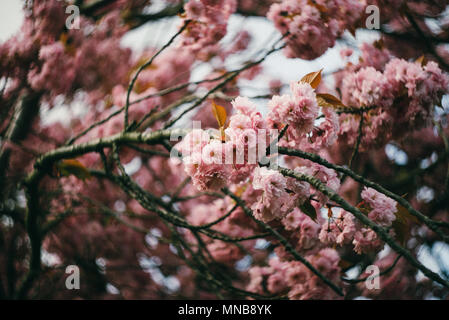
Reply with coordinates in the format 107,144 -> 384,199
28,12 -> 131,103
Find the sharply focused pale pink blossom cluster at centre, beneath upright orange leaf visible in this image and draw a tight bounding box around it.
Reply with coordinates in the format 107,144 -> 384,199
176,97 -> 269,190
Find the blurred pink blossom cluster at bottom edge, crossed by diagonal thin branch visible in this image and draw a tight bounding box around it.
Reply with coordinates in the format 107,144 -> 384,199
246,248 -> 340,300
